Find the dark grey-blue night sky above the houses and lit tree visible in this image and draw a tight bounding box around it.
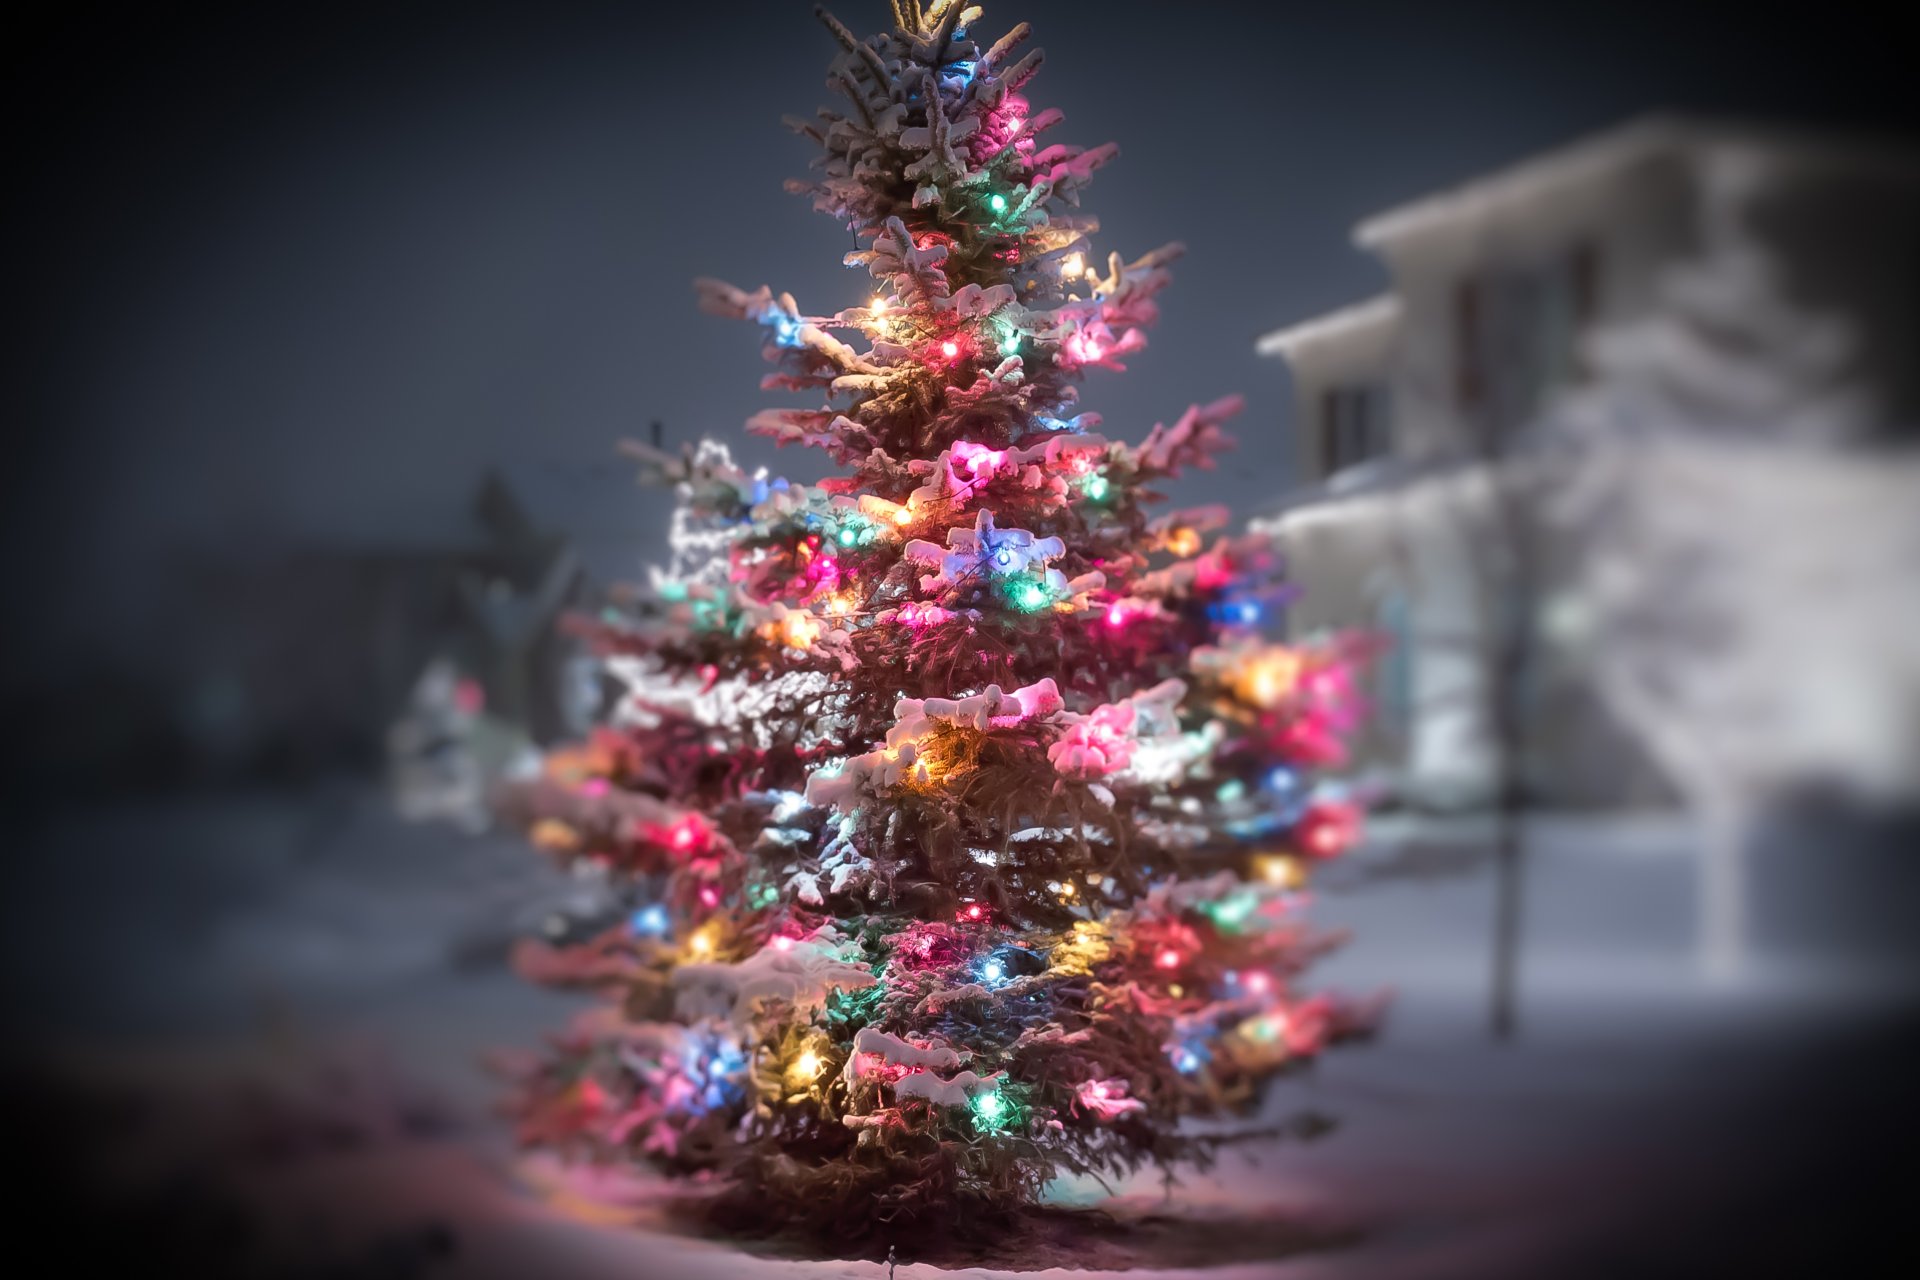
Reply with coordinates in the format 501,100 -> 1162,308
6,0 -> 1914,677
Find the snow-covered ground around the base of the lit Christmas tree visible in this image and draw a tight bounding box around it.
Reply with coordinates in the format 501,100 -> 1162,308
0,785 -> 1920,1280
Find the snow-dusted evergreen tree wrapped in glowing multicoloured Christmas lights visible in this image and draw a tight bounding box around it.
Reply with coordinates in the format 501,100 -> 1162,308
518,0 -> 1367,1238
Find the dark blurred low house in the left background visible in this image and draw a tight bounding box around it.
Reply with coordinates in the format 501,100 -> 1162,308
148,474 -> 588,777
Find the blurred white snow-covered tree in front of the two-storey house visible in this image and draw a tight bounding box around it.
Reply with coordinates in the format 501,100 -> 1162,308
1536,144 -> 1920,979
